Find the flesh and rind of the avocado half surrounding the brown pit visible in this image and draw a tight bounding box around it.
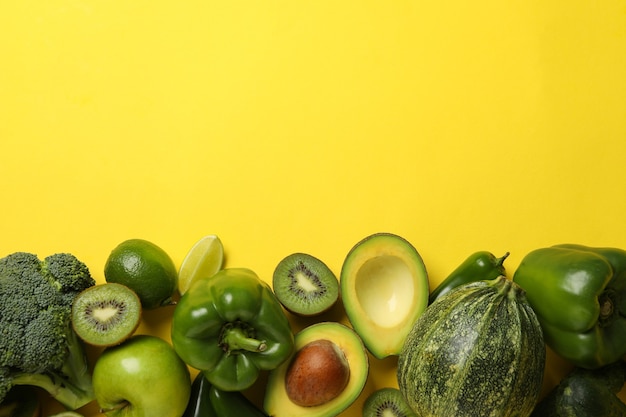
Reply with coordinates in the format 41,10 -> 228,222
263,322 -> 369,417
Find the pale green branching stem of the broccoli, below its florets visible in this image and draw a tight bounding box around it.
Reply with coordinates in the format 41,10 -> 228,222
12,331 -> 96,410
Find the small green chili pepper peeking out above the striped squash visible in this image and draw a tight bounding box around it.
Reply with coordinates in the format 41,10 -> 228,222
428,251 -> 509,304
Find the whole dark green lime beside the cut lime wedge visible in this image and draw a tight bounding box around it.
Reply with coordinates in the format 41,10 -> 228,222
104,239 -> 178,309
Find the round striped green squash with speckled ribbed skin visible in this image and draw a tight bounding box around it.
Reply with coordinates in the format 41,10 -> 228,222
397,276 -> 546,417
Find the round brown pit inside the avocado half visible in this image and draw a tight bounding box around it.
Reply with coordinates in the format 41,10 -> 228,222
285,339 -> 350,407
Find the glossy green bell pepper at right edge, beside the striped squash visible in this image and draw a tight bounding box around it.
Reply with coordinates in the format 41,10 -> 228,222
513,244 -> 626,369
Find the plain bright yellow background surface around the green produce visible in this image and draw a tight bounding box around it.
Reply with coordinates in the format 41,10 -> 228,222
0,0 -> 626,416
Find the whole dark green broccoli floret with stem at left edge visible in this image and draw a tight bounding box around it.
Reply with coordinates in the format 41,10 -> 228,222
0,252 -> 95,410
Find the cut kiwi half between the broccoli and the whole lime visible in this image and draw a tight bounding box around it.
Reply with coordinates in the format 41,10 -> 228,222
72,283 -> 142,346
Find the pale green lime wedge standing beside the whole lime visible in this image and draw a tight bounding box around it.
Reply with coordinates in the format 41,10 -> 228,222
178,235 -> 224,295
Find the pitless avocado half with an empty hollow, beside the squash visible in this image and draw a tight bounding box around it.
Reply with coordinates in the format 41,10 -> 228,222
340,233 -> 429,359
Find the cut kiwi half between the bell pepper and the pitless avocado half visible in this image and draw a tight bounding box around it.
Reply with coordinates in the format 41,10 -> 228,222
272,253 -> 339,316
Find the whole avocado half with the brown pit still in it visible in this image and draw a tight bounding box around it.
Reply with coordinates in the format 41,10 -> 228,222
264,322 -> 369,417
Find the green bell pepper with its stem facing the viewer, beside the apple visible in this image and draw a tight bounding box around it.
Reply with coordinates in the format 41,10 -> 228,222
171,268 -> 294,391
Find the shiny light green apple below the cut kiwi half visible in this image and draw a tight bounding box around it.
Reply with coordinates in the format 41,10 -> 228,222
93,335 -> 191,417
